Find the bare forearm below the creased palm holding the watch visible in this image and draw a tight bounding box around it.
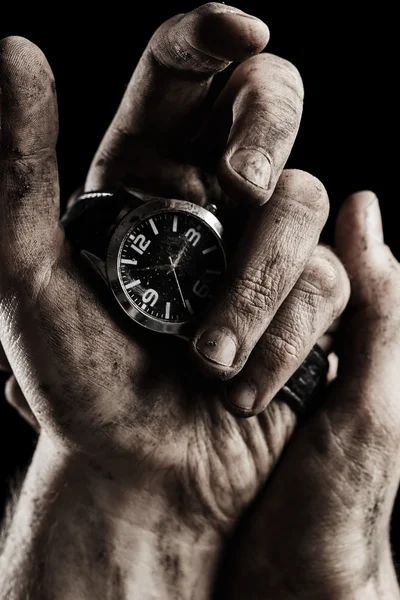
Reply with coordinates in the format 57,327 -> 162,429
0,438 -> 221,600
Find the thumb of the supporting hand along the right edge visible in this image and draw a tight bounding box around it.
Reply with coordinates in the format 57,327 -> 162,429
324,191 -> 400,510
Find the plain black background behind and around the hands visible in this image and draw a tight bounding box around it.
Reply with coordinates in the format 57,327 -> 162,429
0,2 -> 400,564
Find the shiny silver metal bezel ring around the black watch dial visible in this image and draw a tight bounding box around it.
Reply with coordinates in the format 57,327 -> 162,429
106,198 -> 226,337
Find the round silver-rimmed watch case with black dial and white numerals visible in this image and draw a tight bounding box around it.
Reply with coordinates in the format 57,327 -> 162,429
107,200 -> 226,334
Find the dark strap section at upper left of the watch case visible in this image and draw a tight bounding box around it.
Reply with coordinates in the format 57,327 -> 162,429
61,190 -> 142,260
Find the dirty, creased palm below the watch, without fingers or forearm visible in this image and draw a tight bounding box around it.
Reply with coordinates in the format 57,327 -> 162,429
17,252 -> 290,528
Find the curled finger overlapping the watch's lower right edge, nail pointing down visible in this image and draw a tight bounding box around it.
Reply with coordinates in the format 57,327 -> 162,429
193,171 -> 328,379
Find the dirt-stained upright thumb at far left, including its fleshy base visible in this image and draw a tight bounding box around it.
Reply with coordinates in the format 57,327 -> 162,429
0,38 -> 147,444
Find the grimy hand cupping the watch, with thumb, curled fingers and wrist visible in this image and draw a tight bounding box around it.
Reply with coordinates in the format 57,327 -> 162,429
0,4 -> 349,598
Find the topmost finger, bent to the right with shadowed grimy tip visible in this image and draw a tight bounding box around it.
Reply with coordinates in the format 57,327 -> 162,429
86,2 -> 269,189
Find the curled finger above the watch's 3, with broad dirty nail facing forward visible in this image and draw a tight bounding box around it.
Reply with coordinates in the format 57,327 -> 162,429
197,54 -> 304,205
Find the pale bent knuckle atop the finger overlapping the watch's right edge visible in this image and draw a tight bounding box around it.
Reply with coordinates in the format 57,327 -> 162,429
276,169 -> 329,222
